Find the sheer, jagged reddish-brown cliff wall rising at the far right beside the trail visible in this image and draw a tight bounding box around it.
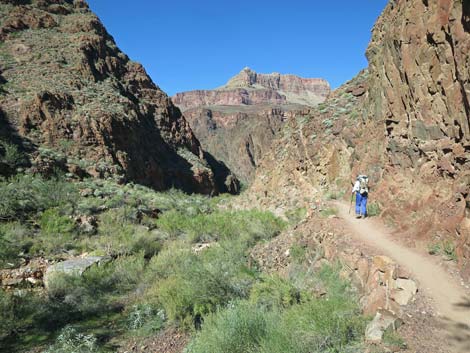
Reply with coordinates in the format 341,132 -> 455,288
366,0 -> 470,278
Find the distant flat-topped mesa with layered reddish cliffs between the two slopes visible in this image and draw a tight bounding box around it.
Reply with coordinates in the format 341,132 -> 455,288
172,68 -> 330,183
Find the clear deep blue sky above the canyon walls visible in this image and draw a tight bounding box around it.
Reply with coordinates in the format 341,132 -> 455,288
89,0 -> 387,95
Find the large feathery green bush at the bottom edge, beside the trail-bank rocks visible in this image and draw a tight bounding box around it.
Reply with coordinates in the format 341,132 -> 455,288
187,267 -> 366,353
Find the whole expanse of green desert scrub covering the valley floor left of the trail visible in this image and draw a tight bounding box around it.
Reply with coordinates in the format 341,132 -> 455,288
0,141 -> 364,353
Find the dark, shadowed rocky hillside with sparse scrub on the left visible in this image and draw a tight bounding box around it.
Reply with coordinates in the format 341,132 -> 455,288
0,0 -> 237,193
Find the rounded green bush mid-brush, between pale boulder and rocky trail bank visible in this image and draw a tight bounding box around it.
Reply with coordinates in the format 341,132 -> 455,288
146,236 -> 253,328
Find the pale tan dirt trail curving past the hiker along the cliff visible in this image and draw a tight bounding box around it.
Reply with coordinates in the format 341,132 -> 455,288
335,202 -> 470,353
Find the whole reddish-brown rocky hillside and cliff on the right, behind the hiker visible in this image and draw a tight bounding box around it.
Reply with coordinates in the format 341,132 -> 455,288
253,0 -> 470,279
